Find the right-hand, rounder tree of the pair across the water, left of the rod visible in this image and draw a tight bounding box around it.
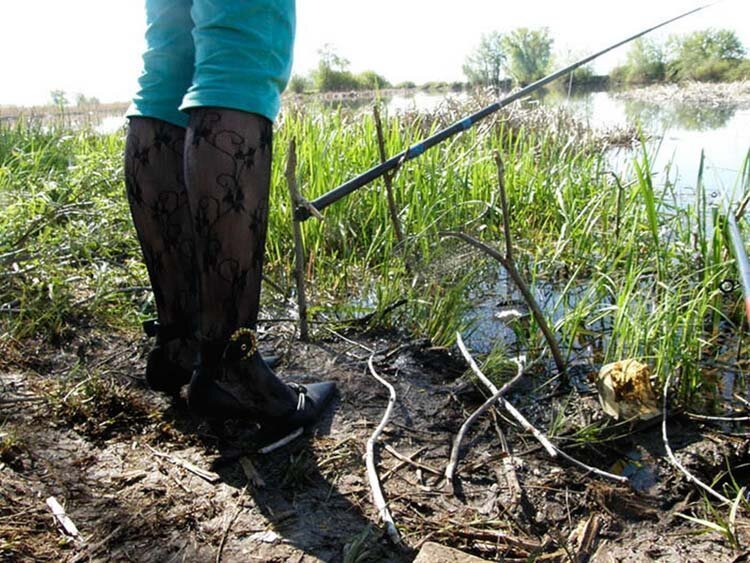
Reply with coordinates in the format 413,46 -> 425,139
501,27 -> 553,86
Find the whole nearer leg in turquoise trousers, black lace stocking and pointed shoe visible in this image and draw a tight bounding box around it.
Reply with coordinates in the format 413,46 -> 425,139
181,0 -> 333,431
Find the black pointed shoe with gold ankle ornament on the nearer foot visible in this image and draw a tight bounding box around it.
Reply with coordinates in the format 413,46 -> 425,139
188,329 -> 335,443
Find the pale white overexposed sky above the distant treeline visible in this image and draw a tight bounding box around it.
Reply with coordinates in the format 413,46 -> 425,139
0,0 -> 750,105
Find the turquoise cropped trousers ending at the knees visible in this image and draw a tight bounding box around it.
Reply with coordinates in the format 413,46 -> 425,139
127,0 -> 295,127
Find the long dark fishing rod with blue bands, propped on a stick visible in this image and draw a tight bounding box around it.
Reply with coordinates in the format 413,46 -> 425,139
294,2 -> 717,221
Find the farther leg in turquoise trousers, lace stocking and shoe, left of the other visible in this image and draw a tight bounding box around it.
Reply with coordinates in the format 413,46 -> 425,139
125,0 -> 198,393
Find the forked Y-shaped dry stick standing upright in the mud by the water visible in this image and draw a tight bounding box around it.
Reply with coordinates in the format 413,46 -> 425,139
440,151 -> 565,375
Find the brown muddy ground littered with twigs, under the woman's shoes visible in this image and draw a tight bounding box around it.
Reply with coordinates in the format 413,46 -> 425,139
0,327 -> 748,562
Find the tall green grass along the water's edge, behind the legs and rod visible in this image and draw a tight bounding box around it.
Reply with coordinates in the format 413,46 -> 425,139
0,101 -> 739,406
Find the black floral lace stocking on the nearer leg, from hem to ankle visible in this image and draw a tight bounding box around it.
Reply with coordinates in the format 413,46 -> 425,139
185,108 -> 272,340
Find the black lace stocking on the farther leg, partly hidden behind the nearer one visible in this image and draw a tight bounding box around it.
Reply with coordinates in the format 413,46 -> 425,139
125,117 -> 198,329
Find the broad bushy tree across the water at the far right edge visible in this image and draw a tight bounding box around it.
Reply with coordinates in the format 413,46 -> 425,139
668,29 -> 745,80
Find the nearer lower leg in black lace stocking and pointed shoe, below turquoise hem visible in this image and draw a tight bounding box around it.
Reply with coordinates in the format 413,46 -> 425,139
185,108 -> 333,446
